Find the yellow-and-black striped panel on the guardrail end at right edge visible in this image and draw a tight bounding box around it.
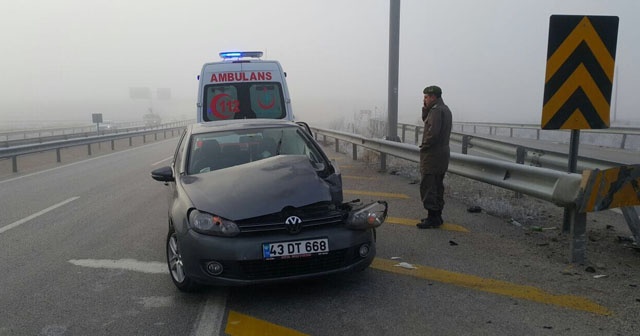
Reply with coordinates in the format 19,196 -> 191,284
578,164 -> 640,212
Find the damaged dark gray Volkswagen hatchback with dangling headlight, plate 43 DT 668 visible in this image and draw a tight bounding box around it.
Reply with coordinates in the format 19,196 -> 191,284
151,119 -> 387,291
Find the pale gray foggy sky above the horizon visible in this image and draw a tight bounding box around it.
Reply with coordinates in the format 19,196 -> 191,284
0,0 -> 640,126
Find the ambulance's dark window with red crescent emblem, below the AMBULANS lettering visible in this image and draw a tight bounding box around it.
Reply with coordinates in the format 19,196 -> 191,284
203,82 -> 286,121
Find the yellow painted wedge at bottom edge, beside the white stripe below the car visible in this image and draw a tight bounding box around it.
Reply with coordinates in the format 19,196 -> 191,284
224,310 -> 307,336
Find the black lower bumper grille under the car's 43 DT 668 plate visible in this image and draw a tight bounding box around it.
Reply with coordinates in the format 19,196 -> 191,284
236,249 -> 352,280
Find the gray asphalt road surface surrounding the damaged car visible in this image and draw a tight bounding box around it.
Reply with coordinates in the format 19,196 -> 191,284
0,135 -> 640,336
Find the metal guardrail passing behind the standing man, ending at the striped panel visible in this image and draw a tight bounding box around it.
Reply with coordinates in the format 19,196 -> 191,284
311,127 -> 635,263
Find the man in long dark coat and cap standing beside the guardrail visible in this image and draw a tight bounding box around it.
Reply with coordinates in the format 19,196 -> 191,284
416,85 -> 452,229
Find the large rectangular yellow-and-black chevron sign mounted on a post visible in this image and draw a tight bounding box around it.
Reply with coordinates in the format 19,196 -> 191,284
542,15 -> 619,130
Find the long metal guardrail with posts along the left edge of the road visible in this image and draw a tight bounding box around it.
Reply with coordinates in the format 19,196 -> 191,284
0,121 -> 191,173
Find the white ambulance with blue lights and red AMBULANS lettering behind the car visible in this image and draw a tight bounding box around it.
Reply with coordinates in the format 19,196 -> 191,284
197,51 -> 294,122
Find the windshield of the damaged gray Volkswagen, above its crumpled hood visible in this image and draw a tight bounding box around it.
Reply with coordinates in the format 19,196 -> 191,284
187,127 -> 325,175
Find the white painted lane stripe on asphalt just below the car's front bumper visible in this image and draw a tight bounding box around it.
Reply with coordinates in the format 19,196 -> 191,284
191,288 -> 227,336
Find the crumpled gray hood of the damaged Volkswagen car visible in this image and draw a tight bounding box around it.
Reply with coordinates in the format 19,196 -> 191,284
180,155 -> 331,220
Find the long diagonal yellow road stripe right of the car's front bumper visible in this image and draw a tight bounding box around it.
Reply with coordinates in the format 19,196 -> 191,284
371,258 -> 611,315
